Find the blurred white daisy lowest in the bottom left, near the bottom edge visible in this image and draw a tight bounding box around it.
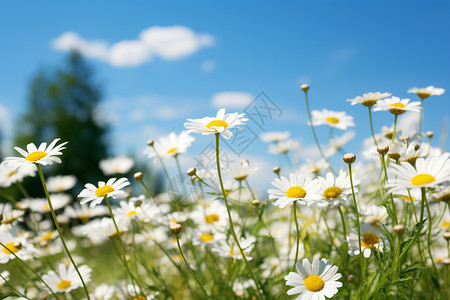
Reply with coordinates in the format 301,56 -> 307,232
42,264 -> 92,293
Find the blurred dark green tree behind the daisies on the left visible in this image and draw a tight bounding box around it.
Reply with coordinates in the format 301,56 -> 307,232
15,52 -> 108,188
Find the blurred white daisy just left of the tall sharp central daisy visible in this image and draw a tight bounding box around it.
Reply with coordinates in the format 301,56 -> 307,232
144,131 -> 195,158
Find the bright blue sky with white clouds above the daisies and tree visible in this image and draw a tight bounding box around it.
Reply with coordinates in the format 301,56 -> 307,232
0,1 -> 450,190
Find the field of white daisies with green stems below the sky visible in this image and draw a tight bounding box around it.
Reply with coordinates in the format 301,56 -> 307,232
0,84 -> 450,300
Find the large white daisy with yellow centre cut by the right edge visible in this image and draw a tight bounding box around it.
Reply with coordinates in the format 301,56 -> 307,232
386,152 -> 450,193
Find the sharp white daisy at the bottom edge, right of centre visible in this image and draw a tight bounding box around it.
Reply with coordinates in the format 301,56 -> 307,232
284,257 -> 342,300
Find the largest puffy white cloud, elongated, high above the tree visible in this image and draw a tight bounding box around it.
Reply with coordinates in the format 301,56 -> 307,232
52,26 -> 214,67
